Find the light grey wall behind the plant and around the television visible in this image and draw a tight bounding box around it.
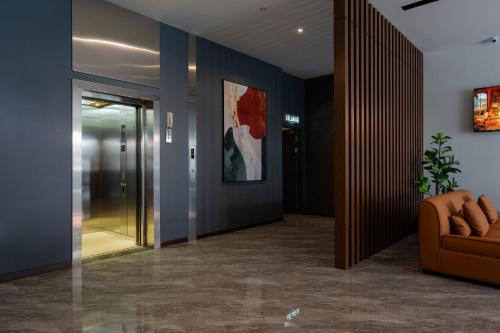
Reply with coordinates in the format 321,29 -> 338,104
424,43 -> 500,208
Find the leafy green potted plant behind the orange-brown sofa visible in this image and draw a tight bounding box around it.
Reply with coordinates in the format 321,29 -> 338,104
416,133 -> 461,195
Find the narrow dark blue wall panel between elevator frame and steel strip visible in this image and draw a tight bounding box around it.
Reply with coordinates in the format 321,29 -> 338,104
160,24 -> 189,242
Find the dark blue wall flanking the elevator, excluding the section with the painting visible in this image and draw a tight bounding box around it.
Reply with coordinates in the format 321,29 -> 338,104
0,4 -> 188,275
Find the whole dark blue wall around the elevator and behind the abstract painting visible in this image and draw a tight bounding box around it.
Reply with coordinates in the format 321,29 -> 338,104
0,0 -> 300,275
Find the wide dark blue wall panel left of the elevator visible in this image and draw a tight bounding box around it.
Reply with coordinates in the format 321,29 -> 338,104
0,0 -> 72,274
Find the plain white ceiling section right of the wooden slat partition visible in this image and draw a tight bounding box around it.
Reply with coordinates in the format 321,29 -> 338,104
370,0 -> 500,53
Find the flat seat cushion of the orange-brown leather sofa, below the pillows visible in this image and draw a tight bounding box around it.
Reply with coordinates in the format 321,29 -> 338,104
441,233 -> 500,258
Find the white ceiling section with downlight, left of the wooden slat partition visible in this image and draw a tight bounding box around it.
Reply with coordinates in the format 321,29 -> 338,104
108,0 -> 332,79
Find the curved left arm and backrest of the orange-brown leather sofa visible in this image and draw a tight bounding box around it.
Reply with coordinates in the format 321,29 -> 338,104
419,190 -> 474,270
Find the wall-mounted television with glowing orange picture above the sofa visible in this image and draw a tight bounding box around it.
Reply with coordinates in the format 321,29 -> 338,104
474,86 -> 500,132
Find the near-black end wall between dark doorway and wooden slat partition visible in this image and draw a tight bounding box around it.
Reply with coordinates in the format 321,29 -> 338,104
304,75 -> 335,216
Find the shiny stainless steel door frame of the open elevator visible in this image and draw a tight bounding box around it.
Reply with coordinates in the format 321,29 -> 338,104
72,79 -> 161,265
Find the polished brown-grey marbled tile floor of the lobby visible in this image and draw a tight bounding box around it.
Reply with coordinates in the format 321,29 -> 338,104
0,216 -> 500,333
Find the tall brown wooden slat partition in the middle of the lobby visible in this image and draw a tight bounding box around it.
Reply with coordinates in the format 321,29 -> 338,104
334,0 -> 423,269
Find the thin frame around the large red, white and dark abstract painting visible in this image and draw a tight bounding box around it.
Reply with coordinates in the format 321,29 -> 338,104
221,78 -> 269,184
